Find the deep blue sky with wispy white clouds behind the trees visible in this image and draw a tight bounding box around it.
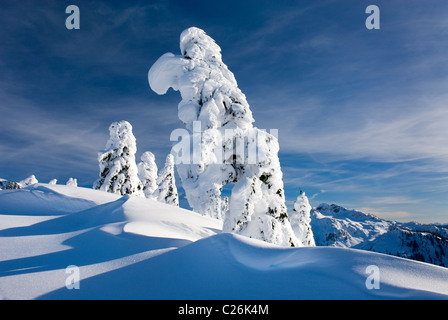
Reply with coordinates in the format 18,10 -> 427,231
0,0 -> 448,222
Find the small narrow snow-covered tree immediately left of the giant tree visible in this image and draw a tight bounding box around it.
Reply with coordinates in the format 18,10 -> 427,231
154,154 -> 179,207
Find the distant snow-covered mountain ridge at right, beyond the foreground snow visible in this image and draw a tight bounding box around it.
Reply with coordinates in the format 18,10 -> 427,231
311,204 -> 448,267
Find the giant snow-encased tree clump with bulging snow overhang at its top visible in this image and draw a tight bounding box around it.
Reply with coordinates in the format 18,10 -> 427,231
148,27 -> 302,246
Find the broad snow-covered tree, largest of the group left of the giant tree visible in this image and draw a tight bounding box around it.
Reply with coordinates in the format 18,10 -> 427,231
93,120 -> 144,196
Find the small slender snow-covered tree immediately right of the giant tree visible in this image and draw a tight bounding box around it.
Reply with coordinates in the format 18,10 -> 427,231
289,190 -> 316,247
